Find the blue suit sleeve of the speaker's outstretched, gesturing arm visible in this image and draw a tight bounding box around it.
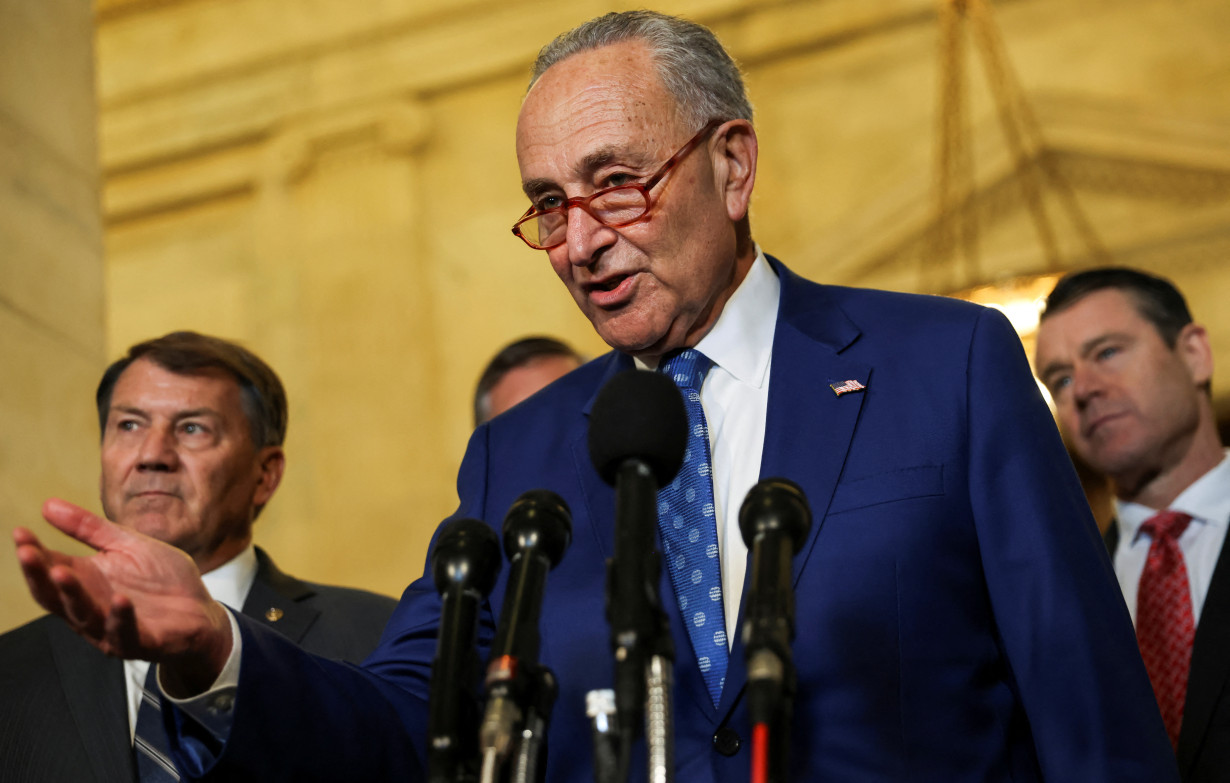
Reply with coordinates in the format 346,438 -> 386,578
166,428 -> 504,783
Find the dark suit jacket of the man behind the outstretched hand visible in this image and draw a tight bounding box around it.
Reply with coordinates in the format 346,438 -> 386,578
0,548 -> 396,783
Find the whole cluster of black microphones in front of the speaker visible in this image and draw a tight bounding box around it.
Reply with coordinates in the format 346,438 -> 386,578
428,370 -> 812,783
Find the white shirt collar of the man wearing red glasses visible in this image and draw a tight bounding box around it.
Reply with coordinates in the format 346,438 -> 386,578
636,246 -> 781,388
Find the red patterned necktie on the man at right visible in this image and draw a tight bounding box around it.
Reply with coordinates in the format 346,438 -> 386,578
1137,511 -> 1196,747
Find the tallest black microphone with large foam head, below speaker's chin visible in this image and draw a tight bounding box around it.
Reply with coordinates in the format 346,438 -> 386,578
589,370 -> 688,750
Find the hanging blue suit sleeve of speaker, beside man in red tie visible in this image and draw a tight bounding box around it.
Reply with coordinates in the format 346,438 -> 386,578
967,310 -> 1178,783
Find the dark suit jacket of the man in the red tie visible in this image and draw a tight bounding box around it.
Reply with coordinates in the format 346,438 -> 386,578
1105,521 -> 1230,783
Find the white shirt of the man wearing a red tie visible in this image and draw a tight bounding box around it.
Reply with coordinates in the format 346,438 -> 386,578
1114,451 -> 1230,624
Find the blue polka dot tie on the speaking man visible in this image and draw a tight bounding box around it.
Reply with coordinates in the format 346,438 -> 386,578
658,348 -> 729,707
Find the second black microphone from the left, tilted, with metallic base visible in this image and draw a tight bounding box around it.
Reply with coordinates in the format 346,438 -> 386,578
478,489 -> 572,778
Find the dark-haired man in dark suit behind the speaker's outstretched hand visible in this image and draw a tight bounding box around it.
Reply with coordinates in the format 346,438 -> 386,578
0,332 -> 396,783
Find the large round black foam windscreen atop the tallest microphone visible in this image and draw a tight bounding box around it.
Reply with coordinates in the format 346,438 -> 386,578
589,370 -> 688,487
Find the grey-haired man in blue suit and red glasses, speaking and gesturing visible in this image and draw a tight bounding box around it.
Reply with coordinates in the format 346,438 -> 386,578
18,11 -> 1176,783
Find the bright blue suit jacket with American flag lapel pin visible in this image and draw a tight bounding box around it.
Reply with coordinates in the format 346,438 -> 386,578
170,262 -> 1177,783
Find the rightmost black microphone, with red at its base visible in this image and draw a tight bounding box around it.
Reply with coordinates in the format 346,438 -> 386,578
739,478 -> 812,723
